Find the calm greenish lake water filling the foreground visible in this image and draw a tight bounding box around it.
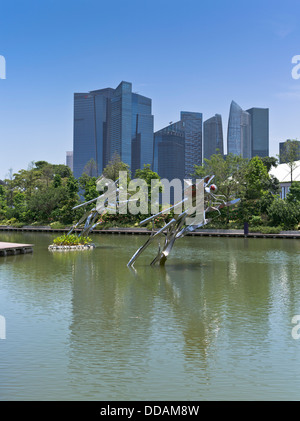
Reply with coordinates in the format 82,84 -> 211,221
0,232 -> 300,401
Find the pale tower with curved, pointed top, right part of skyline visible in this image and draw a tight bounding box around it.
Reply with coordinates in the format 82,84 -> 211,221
227,101 -> 252,159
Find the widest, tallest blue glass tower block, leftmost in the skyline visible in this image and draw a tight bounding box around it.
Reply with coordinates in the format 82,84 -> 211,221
73,82 -> 153,177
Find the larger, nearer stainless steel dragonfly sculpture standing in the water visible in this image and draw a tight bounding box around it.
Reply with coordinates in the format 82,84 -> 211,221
127,176 -> 239,267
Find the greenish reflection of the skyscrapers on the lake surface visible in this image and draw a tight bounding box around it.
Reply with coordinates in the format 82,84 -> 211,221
63,235 -> 300,398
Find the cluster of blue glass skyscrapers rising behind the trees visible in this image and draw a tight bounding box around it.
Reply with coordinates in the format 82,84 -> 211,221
71,81 -> 269,179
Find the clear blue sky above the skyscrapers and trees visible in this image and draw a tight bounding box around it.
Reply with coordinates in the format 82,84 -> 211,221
0,0 -> 300,179
